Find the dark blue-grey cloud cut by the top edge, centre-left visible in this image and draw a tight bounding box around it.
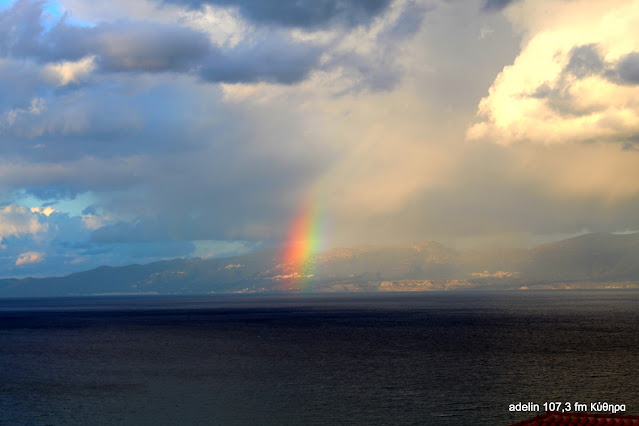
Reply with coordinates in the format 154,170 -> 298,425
163,0 -> 392,29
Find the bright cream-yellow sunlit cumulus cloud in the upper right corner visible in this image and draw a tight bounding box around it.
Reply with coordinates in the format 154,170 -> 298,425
468,0 -> 639,145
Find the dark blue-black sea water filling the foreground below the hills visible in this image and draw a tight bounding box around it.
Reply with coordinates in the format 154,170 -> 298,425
0,291 -> 639,425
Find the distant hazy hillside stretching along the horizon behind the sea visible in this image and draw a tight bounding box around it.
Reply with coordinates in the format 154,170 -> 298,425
0,234 -> 639,297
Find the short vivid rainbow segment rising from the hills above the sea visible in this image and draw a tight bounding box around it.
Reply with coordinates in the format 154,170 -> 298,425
282,194 -> 326,292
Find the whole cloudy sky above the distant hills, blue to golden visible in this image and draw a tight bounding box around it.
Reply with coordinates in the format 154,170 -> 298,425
0,0 -> 639,277
